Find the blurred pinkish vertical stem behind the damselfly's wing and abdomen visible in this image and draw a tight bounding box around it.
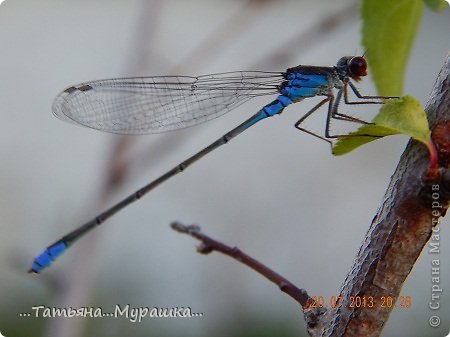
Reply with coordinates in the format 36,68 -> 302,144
45,0 -> 162,337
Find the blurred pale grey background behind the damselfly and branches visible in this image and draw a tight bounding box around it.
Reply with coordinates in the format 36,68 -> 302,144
0,0 -> 450,337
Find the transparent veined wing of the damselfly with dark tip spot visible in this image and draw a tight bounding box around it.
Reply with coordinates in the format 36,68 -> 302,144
52,71 -> 283,134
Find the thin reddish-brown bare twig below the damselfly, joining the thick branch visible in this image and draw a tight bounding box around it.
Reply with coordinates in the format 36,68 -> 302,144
171,222 -> 310,308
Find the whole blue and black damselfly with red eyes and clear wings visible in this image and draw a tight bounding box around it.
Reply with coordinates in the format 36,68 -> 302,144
30,56 -> 390,273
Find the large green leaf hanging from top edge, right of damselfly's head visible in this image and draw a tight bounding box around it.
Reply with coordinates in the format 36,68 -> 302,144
361,0 -> 424,96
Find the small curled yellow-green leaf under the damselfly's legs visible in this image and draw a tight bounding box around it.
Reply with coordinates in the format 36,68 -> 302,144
332,96 -> 431,156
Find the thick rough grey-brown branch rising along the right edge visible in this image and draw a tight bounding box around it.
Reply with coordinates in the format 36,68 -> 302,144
309,54 -> 450,337
